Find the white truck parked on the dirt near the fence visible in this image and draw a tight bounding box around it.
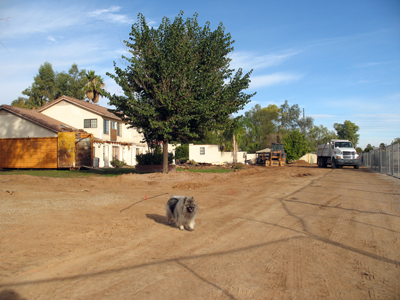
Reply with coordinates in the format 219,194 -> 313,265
317,140 -> 360,169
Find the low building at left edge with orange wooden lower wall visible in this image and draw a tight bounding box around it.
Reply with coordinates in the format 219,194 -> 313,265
0,105 -> 93,168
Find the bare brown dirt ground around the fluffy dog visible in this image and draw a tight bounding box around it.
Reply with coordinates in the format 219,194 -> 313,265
0,163 -> 400,300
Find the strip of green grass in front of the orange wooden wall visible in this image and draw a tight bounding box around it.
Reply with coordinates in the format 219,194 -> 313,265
0,168 -> 135,178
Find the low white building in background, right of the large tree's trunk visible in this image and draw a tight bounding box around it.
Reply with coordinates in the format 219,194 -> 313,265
189,144 -> 247,165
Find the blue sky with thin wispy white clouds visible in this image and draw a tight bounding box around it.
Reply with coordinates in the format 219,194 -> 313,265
0,0 -> 400,149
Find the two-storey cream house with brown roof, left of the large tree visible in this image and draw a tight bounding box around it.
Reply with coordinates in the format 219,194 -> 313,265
37,96 -> 148,167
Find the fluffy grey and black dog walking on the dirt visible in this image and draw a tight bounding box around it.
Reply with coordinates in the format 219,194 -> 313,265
165,196 -> 198,230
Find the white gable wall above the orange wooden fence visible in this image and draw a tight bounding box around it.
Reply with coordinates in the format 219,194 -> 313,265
0,110 -> 58,138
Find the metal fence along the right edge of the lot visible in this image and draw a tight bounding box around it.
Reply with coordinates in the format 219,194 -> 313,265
361,143 -> 400,178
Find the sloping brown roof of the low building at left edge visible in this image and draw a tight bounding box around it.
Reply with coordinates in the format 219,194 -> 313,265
0,104 -> 84,133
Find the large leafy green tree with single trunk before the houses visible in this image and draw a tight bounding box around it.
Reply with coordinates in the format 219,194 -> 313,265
107,12 -> 253,173
